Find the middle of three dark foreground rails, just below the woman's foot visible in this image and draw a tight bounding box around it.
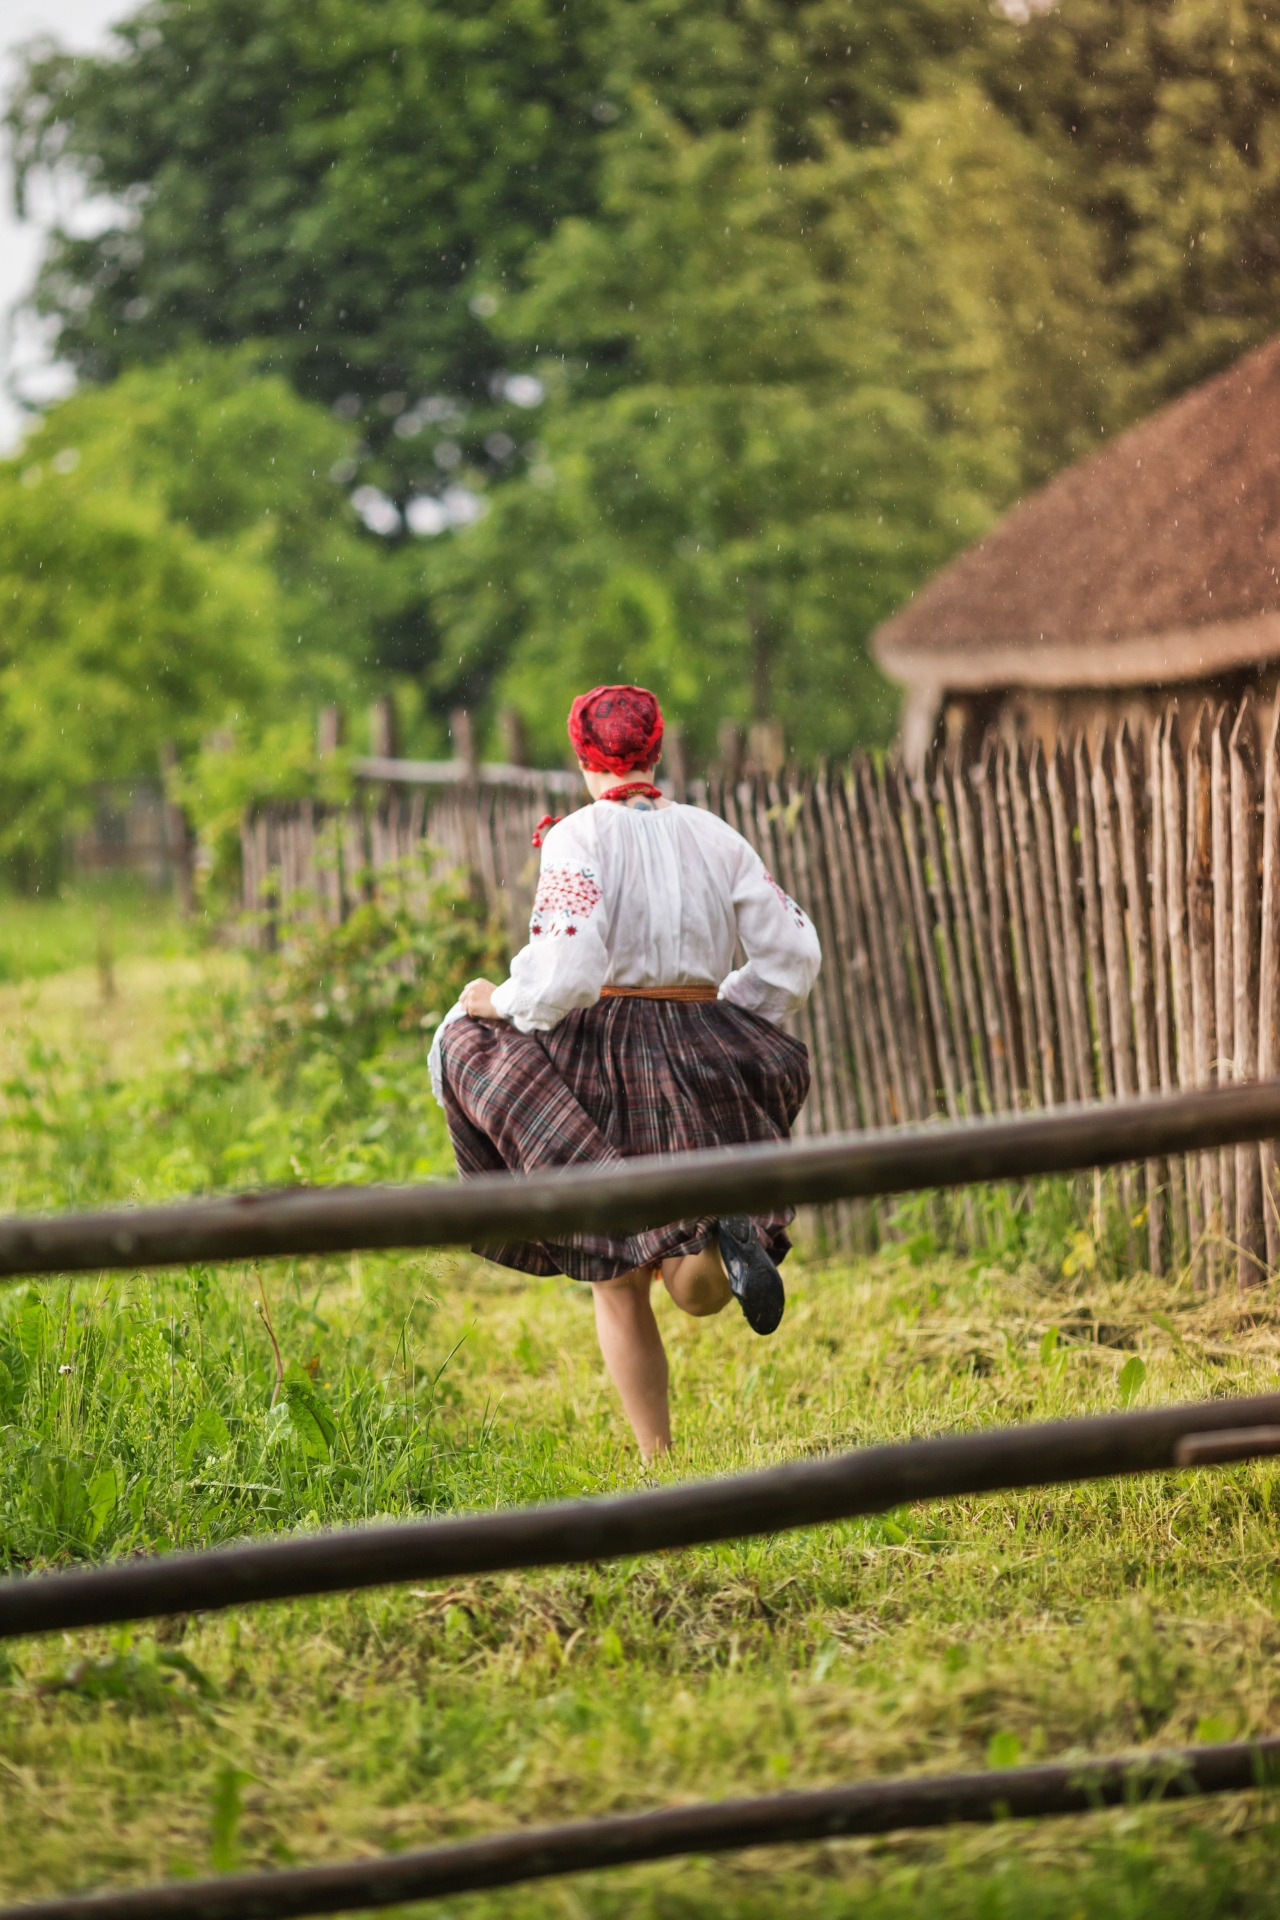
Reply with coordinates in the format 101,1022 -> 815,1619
0,1394 -> 1280,1640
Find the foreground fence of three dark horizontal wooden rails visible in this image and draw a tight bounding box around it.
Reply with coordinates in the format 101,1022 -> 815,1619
12,1081 -> 1280,1920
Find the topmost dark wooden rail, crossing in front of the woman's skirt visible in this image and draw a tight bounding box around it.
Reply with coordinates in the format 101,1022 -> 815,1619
0,1081 -> 1280,1279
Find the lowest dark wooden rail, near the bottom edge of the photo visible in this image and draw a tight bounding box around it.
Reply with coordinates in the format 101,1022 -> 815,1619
0,1740 -> 1280,1920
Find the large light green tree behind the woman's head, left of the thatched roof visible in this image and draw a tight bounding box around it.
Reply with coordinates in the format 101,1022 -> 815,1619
436,88 -> 1109,755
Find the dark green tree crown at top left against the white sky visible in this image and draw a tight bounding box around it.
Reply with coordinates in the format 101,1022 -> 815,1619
10,0 -> 597,412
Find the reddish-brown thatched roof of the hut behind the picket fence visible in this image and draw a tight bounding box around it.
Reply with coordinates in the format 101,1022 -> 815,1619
873,336 -> 1280,697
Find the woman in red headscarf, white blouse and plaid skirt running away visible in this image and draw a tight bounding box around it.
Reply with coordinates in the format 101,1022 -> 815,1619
432,687 -> 821,1459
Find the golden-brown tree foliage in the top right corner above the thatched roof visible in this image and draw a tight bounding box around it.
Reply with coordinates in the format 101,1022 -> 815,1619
983,0 -> 1280,411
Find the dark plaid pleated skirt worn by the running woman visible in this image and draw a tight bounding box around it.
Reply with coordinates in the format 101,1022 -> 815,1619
441,996 -> 810,1281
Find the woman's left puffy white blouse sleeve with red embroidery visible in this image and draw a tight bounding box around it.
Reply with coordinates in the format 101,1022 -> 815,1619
493,808 -> 608,1033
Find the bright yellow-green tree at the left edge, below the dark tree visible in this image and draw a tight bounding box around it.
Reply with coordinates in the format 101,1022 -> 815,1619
0,464 -> 282,885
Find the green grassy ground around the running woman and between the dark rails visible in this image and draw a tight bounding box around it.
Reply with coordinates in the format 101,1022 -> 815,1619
0,906 -> 1280,1920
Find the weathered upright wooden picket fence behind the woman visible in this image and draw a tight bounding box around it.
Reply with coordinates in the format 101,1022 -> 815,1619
244,693 -> 1280,1286
